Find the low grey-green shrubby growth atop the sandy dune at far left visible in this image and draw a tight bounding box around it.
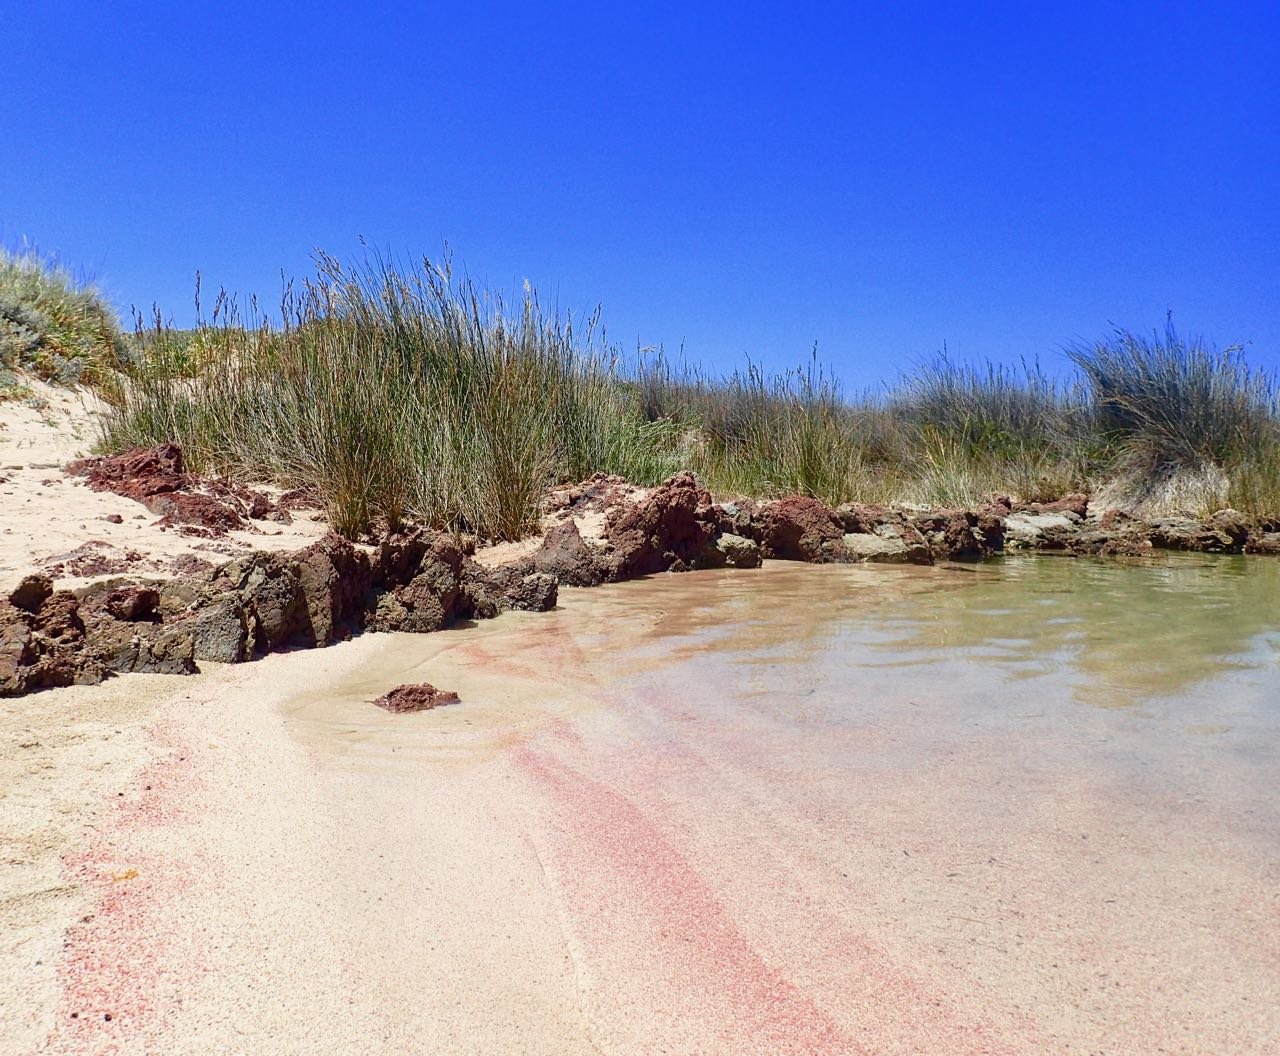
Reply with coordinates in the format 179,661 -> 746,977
0,248 -> 129,392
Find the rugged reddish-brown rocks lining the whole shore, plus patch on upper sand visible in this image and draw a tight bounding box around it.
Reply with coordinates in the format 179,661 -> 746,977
0,445 -> 1280,696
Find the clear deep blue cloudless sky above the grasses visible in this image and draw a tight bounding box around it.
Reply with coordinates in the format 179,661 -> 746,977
0,0 -> 1280,385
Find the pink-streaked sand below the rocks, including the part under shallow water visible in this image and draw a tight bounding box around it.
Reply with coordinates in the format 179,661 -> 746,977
0,559 -> 1280,1053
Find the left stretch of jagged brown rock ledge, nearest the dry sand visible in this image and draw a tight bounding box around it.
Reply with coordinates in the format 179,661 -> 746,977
0,531 -> 558,696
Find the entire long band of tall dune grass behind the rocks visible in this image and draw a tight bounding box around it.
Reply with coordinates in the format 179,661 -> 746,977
102,257 -> 1280,539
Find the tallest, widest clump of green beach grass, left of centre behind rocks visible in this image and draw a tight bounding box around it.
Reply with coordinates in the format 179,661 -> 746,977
104,257 -> 678,539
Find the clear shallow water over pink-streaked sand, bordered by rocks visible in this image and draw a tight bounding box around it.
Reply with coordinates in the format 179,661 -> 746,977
292,557 -> 1280,1053
